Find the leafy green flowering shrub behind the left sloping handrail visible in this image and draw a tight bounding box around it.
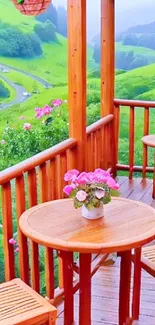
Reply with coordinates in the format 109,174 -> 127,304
0,106 -> 68,170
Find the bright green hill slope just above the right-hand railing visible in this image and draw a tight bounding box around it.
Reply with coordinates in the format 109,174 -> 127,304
116,64 -> 155,100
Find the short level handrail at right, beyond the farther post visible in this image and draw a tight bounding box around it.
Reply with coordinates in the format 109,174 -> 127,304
114,99 -> 155,108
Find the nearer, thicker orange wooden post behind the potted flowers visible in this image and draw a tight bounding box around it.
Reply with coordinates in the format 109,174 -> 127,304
68,0 -> 86,171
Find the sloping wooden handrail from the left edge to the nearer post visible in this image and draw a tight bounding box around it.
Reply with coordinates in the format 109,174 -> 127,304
0,138 -> 77,185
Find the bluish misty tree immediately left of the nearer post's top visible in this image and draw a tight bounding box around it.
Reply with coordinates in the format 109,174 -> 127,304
56,6 -> 67,37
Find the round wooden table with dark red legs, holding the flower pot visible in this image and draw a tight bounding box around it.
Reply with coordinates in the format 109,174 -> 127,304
19,198 -> 155,325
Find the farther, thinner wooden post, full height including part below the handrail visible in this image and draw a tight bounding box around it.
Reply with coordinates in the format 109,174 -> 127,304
101,0 -> 118,176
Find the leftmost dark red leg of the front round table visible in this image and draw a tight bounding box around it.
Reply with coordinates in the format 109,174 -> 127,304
61,252 -> 74,325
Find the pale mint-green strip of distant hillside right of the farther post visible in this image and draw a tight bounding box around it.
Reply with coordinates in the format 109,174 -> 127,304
116,42 -> 155,64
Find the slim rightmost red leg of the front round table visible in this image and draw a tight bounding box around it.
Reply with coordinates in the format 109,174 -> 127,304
132,248 -> 141,320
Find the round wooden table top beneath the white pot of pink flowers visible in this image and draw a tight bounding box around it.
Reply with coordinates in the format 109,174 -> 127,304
19,198 -> 155,253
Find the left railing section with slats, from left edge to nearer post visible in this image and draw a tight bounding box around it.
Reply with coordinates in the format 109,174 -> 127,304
0,139 -> 77,297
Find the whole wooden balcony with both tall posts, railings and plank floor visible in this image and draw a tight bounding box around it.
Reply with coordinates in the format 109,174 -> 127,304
0,0 -> 155,325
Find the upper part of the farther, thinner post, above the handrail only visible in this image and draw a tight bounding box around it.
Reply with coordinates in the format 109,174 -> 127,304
101,0 -> 115,117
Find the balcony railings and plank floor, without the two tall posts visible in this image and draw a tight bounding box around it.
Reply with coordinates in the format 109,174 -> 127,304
0,100 -> 155,325
